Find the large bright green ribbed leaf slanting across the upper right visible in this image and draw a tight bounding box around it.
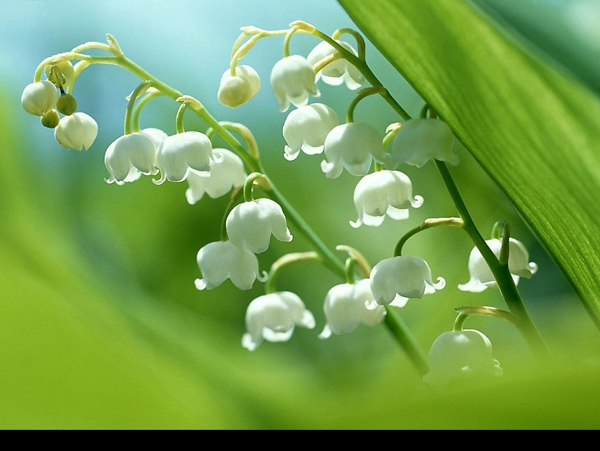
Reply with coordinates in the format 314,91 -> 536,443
340,0 -> 600,325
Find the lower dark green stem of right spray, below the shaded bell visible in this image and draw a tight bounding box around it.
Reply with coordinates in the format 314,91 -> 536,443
435,160 -> 552,361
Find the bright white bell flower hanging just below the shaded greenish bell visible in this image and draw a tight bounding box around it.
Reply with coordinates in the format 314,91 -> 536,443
350,170 -> 423,228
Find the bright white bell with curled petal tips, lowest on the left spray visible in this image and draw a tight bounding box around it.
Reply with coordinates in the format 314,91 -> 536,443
242,291 -> 315,351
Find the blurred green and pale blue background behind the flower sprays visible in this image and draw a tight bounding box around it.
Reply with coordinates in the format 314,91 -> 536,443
0,0 -> 600,429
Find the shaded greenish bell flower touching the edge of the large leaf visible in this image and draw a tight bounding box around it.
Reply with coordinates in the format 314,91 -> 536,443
386,118 -> 459,168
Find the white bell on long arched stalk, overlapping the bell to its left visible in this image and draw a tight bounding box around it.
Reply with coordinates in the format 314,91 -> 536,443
370,255 -> 446,305
